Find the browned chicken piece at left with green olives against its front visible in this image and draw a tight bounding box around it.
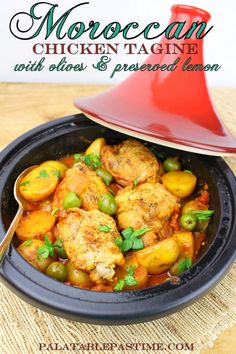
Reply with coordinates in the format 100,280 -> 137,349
52,163 -> 108,210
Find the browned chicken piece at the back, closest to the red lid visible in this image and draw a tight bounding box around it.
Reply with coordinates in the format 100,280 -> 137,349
101,139 -> 159,186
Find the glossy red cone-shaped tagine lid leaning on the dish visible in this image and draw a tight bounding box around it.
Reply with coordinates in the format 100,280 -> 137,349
75,5 -> 236,155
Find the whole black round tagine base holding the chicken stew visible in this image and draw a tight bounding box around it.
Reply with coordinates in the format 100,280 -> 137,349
0,115 -> 236,324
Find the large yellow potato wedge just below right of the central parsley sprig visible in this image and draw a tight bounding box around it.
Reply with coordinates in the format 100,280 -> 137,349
135,238 -> 180,274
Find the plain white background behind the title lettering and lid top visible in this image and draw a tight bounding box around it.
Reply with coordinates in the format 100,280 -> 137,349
0,0 -> 236,86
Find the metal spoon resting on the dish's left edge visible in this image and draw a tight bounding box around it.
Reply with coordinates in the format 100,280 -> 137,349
0,165 -> 37,264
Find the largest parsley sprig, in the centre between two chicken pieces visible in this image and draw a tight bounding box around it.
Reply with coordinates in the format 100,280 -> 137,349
118,227 -> 151,252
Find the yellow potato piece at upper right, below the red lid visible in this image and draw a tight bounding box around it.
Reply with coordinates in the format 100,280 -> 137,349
161,171 -> 197,198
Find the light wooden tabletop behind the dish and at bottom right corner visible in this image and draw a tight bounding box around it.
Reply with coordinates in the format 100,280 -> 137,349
0,83 -> 236,354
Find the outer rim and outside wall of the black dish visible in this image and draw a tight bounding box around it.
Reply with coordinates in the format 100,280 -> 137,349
0,115 -> 236,324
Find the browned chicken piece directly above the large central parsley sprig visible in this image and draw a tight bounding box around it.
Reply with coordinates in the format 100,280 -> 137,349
116,182 -> 179,247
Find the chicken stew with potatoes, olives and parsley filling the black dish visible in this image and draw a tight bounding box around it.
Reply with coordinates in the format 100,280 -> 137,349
16,138 -> 214,291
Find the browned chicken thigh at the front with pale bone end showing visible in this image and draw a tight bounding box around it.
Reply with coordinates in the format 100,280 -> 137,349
57,209 -> 125,284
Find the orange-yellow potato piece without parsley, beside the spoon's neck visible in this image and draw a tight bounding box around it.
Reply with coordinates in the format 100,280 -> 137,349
16,210 -> 55,241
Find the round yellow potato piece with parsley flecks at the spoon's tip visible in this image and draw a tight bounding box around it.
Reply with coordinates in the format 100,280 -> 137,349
20,165 -> 59,203
